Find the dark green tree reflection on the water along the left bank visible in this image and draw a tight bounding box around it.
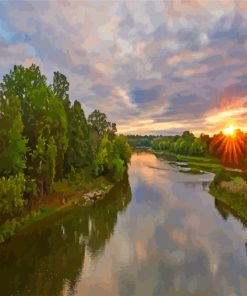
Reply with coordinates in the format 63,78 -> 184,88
0,179 -> 131,296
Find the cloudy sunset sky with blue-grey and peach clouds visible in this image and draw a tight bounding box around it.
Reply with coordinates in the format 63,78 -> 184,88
0,0 -> 247,134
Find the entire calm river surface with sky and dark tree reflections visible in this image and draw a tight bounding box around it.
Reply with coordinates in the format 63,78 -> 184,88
0,152 -> 247,296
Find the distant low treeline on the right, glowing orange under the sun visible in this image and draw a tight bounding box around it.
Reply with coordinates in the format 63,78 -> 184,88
127,130 -> 247,169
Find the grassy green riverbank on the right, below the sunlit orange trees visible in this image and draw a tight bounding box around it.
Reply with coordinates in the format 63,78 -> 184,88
151,150 -> 247,225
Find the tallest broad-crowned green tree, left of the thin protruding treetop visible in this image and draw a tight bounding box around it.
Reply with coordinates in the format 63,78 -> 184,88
0,65 -> 68,190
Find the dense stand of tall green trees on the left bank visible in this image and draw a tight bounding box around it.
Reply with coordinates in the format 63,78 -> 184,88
0,64 -> 131,224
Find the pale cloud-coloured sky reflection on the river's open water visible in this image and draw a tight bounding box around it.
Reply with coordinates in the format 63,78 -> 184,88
77,154 -> 247,295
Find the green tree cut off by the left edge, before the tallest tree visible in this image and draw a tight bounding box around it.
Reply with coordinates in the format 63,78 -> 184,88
0,95 -> 27,176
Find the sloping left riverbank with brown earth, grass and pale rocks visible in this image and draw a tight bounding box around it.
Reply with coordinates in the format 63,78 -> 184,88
0,175 -> 114,243
